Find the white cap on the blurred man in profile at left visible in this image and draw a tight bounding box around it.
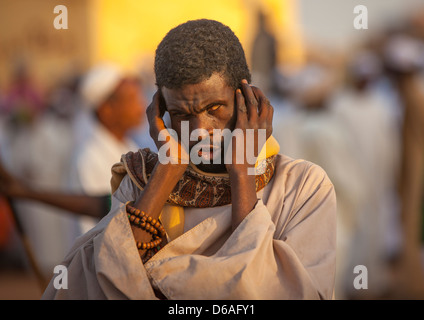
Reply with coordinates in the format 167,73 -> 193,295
80,64 -> 124,109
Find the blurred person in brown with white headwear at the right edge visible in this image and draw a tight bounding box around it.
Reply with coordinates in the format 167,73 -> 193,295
382,31 -> 424,299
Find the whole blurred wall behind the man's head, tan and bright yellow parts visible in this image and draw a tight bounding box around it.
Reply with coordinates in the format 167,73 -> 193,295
0,0 -> 302,89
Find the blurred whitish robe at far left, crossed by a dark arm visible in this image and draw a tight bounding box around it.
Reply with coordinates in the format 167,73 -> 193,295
1,114 -> 75,275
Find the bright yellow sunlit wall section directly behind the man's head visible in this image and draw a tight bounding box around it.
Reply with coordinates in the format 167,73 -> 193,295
93,0 -> 302,73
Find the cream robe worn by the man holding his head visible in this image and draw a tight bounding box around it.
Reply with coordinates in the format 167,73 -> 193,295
43,155 -> 336,299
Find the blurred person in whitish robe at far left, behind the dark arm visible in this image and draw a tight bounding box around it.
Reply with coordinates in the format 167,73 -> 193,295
0,60 -> 80,273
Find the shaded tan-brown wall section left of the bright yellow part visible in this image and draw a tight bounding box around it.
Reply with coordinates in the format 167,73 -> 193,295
0,0 -> 91,89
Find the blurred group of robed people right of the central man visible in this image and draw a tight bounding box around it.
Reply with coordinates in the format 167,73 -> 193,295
268,11 -> 424,299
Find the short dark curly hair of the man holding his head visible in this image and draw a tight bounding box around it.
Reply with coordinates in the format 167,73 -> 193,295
155,19 -> 251,89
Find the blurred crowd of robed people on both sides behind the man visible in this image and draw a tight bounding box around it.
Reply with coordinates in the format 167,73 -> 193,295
0,6 -> 424,299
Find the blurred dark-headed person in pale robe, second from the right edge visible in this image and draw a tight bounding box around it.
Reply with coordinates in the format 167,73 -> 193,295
331,50 -> 400,298
